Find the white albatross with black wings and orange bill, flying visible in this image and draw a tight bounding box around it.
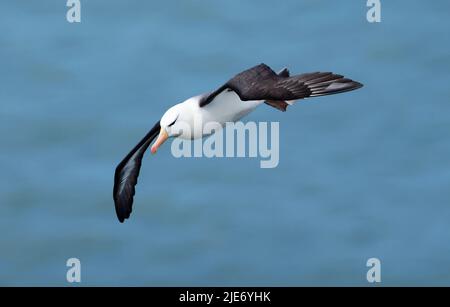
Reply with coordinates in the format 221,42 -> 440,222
113,64 -> 362,223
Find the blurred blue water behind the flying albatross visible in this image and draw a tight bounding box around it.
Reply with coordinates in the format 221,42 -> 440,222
0,0 -> 450,285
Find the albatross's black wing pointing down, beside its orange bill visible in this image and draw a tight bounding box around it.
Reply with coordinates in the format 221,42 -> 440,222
113,122 -> 161,223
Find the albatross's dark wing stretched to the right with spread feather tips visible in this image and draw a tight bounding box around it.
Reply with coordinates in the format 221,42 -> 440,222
200,64 -> 362,107
